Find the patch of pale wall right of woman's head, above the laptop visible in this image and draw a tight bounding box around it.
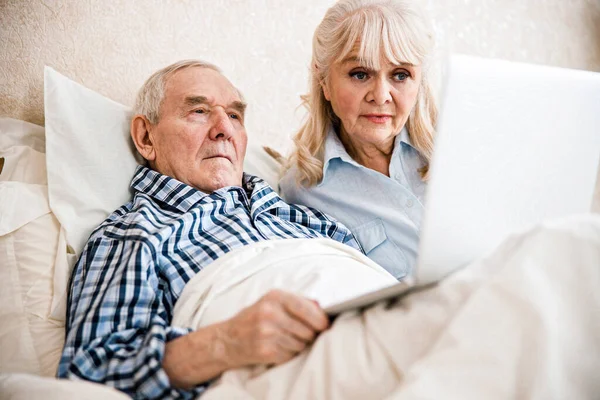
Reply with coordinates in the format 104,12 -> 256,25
428,0 -> 600,71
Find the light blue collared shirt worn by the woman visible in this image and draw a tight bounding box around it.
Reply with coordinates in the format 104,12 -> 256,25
279,128 -> 426,279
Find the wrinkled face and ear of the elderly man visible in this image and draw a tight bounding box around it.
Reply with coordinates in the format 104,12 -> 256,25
149,67 -> 248,193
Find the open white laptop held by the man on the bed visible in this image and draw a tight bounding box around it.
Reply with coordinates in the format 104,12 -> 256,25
325,55 -> 600,317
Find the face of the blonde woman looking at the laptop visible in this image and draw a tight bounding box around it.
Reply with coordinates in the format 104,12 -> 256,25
322,54 -> 421,150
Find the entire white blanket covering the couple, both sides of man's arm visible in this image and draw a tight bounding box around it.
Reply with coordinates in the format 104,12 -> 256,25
174,216 -> 600,400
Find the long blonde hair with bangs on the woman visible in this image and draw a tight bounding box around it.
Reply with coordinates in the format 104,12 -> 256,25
287,0 -> 437,186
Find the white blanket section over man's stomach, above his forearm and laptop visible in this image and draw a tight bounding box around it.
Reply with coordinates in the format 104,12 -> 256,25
172,239 -> 398,328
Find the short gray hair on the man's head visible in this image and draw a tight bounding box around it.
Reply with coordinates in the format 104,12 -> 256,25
133,60 -> 221,125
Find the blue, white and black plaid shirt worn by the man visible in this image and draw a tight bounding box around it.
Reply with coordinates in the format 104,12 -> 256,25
58,166 -> 360,399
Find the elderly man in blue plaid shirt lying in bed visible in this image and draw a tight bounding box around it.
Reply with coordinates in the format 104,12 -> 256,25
58,61 -> 359,398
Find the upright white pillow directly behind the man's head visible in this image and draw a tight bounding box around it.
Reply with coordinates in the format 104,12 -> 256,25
44,67 -> 278,254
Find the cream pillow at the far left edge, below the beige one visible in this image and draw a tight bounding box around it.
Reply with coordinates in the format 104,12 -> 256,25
0,182 -> 65,376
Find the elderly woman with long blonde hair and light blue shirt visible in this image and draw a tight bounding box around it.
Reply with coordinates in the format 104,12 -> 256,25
280,0 -> 437,279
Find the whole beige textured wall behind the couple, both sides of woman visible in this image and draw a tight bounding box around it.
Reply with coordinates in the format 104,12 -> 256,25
0,0 -> 600,206
